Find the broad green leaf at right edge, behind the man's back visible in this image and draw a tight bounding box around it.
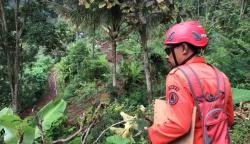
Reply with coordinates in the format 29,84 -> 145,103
232,88 -> 250,104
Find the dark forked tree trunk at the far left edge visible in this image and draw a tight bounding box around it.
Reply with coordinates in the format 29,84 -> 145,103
0,0 -> 29,113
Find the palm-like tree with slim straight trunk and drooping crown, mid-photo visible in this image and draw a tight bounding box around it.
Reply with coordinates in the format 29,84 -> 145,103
79,0 -> 131,89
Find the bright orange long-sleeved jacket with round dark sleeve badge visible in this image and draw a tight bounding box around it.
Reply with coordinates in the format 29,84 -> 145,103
148,56 -> 234,144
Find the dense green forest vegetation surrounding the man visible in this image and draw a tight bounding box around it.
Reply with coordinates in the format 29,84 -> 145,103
0,0 -> 250,144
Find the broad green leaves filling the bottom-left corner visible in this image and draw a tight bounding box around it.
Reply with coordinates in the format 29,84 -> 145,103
0,108 -> 35,144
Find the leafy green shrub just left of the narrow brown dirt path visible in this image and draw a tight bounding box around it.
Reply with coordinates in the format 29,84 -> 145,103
21,50 -> 54,108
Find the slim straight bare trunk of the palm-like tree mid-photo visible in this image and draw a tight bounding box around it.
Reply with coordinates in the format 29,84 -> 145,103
112,40 -> 116,88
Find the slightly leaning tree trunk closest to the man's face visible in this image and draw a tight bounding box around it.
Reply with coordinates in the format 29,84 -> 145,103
139,24 -> 152,104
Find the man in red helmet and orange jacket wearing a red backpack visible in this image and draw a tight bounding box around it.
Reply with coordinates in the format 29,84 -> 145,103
148,21 -> 234,144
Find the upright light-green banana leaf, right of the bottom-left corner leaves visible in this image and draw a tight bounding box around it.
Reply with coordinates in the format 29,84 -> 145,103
35,99 -> 67,138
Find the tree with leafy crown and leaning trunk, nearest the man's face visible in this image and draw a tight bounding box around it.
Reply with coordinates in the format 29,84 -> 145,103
122,0 -> 173,103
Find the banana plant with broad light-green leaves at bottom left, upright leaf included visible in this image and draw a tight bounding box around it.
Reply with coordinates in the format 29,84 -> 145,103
0,99 -> 67,144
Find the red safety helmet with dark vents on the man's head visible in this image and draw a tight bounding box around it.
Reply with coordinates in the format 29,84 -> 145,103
164,21 -> 208,48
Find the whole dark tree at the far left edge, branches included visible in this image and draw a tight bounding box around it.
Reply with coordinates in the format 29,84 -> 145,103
0,0 -> 29,113
